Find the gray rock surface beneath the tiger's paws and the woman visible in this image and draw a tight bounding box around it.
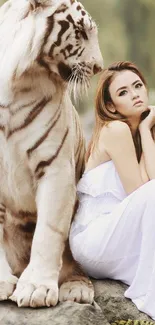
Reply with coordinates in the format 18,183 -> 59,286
0,280 -> 151,325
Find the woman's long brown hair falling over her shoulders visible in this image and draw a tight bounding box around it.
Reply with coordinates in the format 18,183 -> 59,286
86,61 -> 147,162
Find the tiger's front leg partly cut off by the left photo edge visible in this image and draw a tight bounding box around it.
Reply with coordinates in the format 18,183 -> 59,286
0,224 -> 18,301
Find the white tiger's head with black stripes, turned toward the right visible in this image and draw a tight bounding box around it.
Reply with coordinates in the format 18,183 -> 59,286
0,0 -> 103,95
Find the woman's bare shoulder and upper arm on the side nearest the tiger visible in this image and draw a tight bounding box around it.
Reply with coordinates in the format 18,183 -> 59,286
99,121 -> 145,194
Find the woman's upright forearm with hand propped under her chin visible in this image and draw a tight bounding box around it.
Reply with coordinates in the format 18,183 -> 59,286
139,107 -> 155,179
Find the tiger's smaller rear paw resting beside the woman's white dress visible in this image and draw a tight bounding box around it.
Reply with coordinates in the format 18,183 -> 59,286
59,280 -> 94,304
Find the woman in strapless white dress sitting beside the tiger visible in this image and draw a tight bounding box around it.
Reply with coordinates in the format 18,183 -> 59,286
70,62 -> 155,319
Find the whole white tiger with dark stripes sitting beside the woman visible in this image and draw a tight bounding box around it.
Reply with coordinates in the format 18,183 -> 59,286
0,0 -> 102,307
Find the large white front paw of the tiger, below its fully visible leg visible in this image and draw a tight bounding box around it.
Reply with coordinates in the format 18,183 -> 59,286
10,266 -> 58,308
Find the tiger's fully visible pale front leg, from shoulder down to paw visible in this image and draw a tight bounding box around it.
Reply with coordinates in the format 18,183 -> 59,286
10,168 -> 76,307
